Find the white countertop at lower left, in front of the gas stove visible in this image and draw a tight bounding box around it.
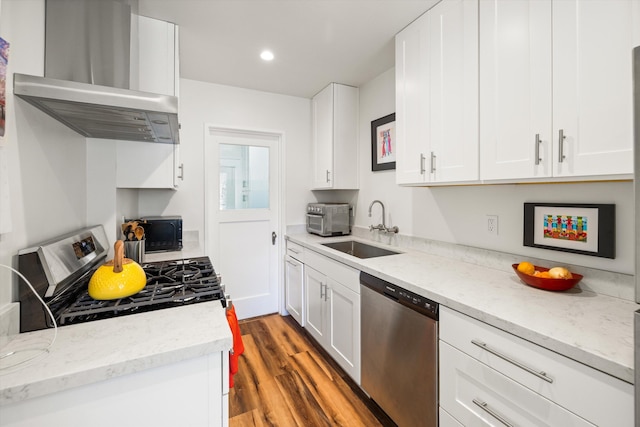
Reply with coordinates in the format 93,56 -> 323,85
0,301 -> 232,405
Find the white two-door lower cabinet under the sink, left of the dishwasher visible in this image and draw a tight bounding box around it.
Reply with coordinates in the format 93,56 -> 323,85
304,251 -> 360,384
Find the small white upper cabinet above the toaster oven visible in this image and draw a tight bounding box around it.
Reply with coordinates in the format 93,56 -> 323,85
312,83 -> 358,190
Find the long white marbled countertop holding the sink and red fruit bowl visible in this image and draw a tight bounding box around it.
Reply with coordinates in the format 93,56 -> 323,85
287,233 -> 640,383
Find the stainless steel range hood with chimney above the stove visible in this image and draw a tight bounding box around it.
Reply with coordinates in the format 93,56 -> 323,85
13,0 -> 179,144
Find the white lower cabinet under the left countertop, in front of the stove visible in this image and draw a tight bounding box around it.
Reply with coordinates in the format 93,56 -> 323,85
0,351 -> 229,427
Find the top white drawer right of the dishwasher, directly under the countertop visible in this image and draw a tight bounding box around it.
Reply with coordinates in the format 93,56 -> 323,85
440,306 -> 633,427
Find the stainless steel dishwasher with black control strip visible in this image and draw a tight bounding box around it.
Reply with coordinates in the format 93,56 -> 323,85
360,272 -> 439,427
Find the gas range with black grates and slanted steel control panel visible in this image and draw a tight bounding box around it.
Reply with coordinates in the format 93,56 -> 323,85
18,226 -> 227,332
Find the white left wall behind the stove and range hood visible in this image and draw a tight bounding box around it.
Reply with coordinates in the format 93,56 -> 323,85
0,0 -> 87,307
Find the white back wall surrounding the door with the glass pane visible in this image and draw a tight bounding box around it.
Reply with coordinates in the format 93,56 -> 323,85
139,79 -> 313,247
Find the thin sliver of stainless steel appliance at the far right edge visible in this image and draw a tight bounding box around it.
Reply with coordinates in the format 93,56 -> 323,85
633,46 -> 640,425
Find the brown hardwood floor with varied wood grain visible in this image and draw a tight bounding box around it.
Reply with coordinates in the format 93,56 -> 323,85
229,314 -> 394,427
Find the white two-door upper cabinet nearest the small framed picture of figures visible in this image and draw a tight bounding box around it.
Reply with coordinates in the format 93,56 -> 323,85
396,0 -> 479,184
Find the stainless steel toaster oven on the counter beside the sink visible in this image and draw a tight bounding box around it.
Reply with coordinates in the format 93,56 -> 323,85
307,203 -> 351,237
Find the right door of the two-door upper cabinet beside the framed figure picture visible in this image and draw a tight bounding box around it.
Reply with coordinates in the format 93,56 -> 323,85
427,0 -> 479,182
